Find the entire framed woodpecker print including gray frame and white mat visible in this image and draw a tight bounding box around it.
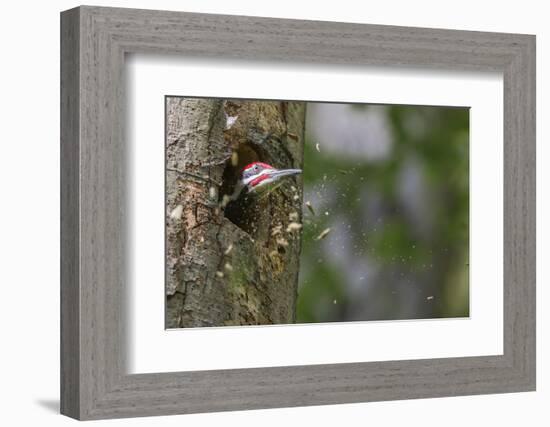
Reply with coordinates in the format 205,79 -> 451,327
61,6 -> 535,419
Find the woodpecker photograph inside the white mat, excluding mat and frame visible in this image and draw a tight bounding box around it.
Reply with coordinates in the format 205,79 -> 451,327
165,95 -> 470,329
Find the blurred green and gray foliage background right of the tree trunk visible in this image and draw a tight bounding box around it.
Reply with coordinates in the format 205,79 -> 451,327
297,104 -> 469,323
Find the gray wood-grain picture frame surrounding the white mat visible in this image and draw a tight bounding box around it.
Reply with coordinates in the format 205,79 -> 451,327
61,6 -> 535,419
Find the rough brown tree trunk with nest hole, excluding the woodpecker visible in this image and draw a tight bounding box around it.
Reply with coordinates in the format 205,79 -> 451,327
166,97 -> 305,328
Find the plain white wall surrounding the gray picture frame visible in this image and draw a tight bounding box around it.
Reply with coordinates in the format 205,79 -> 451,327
0,0 -> 550,427
